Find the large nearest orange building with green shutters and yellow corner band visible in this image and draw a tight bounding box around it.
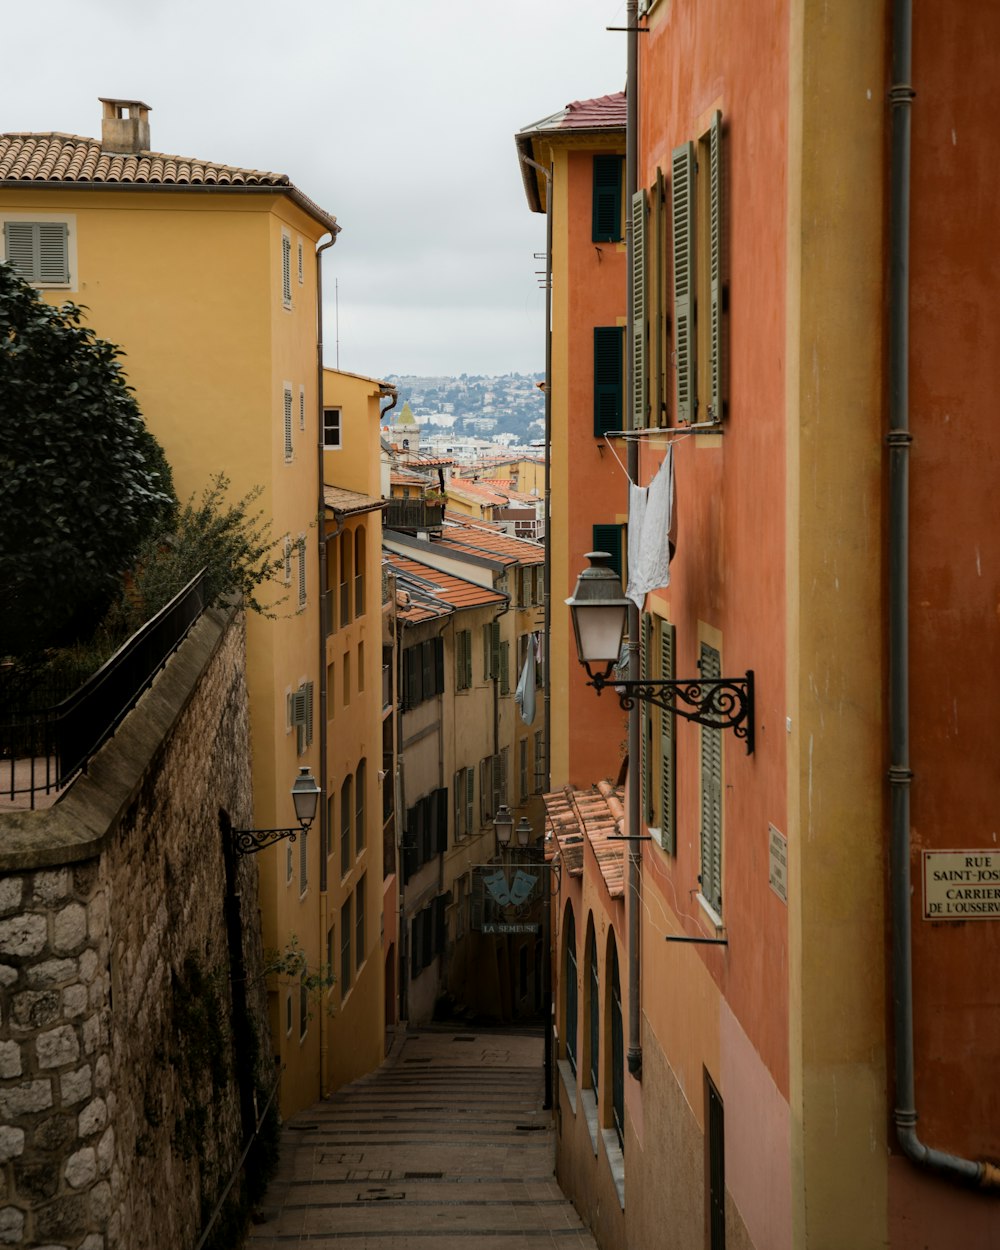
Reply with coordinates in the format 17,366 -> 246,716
548,0 -> 1000,1250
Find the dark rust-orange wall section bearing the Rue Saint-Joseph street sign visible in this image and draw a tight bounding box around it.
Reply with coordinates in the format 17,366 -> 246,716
894,0 -> 1000,1180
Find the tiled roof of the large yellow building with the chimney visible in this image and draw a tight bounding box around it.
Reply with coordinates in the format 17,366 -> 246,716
0,133 -> 340,234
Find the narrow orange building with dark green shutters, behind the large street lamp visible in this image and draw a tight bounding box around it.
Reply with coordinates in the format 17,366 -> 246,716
516,93 -> 628,786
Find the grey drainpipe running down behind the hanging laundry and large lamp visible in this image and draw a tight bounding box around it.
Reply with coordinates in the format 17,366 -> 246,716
625,0 -> 643,1080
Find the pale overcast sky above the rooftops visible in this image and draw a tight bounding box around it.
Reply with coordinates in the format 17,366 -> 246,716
0,0 -> 625,376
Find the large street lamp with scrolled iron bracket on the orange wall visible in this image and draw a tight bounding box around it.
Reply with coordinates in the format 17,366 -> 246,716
566,551 -> 754,755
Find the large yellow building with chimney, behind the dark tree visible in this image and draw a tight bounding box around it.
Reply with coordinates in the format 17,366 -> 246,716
0,100 -> 337,1114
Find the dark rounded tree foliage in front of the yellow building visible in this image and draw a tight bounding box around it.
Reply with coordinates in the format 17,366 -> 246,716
0,265 -> 176,655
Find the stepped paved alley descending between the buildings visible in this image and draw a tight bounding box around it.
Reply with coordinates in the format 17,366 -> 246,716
246,1030 -> 595,1250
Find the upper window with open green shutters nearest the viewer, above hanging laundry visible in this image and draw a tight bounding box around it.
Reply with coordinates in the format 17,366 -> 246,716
671,113 -> 726,423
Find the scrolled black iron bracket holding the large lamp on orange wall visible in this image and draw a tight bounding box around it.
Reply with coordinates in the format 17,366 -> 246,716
585,664 -> 754,755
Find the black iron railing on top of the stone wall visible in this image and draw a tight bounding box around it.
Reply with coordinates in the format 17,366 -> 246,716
0,569 -> 205,806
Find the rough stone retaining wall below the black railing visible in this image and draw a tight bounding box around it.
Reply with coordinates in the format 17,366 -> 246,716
0,610 -> 274,1250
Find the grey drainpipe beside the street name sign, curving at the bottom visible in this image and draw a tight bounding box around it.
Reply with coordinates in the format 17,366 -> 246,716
886,0 -> 1000,1189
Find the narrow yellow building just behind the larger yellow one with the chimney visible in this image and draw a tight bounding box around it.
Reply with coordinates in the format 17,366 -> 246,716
318,369 -> 395,1093
